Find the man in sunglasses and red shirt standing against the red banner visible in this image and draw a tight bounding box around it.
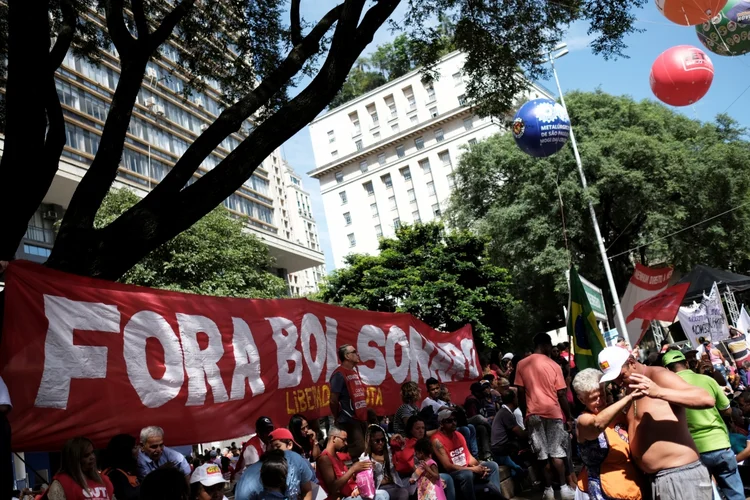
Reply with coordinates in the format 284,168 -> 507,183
330,344 -> 367,457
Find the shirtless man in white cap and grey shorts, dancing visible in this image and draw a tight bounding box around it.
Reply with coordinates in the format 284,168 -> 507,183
599,346 -> 715,500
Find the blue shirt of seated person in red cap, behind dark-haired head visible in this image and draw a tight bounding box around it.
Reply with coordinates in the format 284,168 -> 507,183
234,448 -> 314,500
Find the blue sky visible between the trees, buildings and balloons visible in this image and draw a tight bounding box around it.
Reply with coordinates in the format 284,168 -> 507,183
282,0 -> 750,271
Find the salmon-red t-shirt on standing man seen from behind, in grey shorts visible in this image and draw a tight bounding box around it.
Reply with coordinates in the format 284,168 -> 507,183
516,354 -> 568,419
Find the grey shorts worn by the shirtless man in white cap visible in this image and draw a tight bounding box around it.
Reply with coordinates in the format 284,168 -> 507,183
651,460 -> 714,500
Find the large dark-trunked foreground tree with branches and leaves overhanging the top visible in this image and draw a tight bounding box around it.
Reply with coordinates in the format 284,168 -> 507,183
0,0 -> 646,279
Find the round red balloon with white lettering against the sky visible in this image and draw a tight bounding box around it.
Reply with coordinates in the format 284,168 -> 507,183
649,45 -> 714,106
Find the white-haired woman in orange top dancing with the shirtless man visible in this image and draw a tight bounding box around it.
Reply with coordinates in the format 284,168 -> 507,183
573,368 -> 643,500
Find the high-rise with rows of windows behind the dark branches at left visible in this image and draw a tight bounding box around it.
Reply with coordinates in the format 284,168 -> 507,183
5,31 -> 324,279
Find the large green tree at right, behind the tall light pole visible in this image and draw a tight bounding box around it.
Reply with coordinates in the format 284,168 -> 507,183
450,92 -> 750,338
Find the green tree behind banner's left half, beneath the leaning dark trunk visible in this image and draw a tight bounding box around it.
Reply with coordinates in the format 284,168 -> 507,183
94,189 -> 287,299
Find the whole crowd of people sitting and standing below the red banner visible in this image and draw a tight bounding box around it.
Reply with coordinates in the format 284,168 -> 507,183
13,331 -> 750,500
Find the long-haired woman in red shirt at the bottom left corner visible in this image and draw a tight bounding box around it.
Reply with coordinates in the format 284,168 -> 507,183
42,437 -> 114,500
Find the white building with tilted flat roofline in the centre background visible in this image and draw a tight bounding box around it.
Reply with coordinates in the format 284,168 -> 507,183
309,52 -> 546,268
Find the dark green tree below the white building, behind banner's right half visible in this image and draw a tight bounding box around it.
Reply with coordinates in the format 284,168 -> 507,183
317,223 -> 516,347
